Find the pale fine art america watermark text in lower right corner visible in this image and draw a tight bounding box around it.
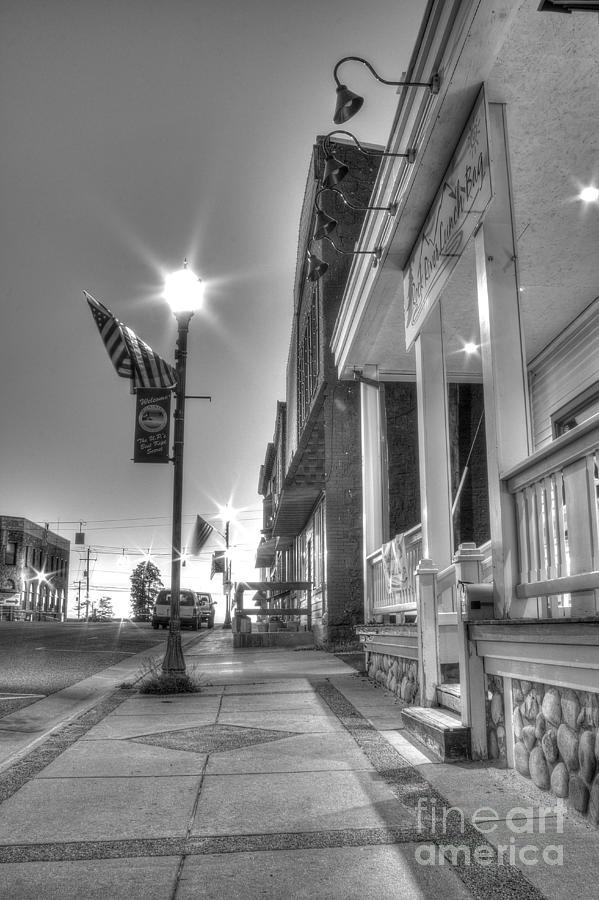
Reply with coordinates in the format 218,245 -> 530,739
414,797 -> 566,866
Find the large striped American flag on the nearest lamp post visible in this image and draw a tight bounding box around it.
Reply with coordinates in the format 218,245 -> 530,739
83,291 -> 177,390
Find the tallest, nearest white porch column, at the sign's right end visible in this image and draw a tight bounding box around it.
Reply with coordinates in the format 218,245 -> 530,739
475,103 -> 536,618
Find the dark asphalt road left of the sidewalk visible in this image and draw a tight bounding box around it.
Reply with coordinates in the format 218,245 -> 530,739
0,620 -> 209,717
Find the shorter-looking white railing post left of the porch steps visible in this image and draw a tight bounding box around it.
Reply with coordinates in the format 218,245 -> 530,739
416,559 -> 441,706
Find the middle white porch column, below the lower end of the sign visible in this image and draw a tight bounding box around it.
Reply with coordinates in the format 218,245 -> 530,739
415,305 -> 453,569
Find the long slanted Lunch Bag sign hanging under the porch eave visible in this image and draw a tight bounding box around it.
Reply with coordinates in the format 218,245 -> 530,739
403,88 -> 493,350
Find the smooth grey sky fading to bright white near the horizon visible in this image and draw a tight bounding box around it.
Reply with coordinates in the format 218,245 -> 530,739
0,0 -> 426,620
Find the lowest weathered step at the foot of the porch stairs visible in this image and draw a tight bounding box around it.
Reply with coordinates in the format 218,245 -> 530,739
401,706 -> 470,762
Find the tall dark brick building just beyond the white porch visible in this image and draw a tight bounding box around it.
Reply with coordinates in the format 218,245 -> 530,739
256,137 -> 380,642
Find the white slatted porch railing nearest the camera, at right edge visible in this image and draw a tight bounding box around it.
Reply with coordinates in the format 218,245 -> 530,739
505,415 -> 599,616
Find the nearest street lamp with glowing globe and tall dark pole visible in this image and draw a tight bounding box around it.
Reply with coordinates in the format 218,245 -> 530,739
162,260 -> 204,675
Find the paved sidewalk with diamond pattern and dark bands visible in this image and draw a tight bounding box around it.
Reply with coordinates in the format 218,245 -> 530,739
0,628 -> 599,900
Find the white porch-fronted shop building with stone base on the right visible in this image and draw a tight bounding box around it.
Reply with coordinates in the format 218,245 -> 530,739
332,0 -> 599,824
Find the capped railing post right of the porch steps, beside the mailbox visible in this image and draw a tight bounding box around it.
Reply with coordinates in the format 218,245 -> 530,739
453,544 -> 488,759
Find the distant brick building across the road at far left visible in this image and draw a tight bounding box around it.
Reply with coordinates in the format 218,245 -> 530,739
0,516 -> 71,621
